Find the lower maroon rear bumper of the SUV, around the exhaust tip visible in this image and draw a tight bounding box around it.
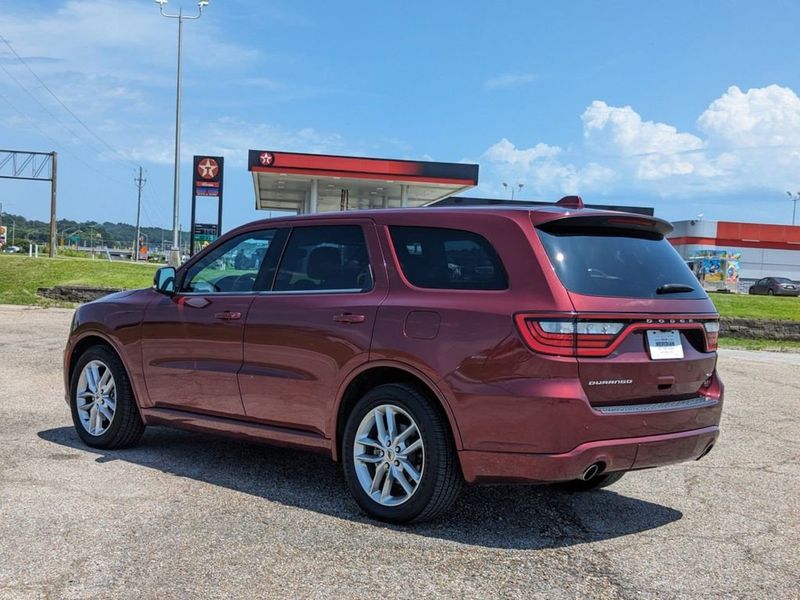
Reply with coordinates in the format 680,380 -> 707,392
459,426 -> 719,483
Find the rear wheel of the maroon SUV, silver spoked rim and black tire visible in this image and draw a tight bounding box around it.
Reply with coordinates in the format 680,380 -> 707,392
342,383 -> 464,523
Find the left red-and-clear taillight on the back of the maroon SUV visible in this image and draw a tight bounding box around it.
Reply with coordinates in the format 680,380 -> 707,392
515,314 -> 626,356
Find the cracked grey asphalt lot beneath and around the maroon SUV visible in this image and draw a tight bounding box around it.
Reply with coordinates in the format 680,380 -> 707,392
0,306 -> 800,599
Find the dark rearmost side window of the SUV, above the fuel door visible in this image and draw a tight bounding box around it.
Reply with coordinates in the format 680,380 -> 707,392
389,227 -> 508,290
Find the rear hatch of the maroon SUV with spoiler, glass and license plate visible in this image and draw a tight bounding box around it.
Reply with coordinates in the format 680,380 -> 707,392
528,213 -> 719,407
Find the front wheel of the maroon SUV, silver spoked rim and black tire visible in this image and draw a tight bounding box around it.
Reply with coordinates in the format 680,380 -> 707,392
69,346 -> 145,449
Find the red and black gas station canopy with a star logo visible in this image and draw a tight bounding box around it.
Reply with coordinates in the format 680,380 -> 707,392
248,150 -> 478,213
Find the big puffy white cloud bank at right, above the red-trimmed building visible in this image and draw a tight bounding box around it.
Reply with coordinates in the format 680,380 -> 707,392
483,85 -> 800,198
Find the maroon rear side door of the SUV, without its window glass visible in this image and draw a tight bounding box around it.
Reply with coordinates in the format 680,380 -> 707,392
239,218 -> 387,437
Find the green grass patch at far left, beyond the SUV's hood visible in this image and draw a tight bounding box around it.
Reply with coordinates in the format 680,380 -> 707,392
0,254 -> 157,306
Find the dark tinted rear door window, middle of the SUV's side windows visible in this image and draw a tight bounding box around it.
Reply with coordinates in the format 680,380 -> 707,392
273,225 -> 372,291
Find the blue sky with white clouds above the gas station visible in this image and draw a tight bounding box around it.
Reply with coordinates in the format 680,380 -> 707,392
0,0 -> 800,237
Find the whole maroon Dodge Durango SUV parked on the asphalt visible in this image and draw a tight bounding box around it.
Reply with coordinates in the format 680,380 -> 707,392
64,197 -> 722,522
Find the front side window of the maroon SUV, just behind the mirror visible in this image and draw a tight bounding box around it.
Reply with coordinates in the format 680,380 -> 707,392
181,229 -> 276,294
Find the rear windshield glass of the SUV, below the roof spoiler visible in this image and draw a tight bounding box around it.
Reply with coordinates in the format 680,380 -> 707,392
538,228 -> 706,299
